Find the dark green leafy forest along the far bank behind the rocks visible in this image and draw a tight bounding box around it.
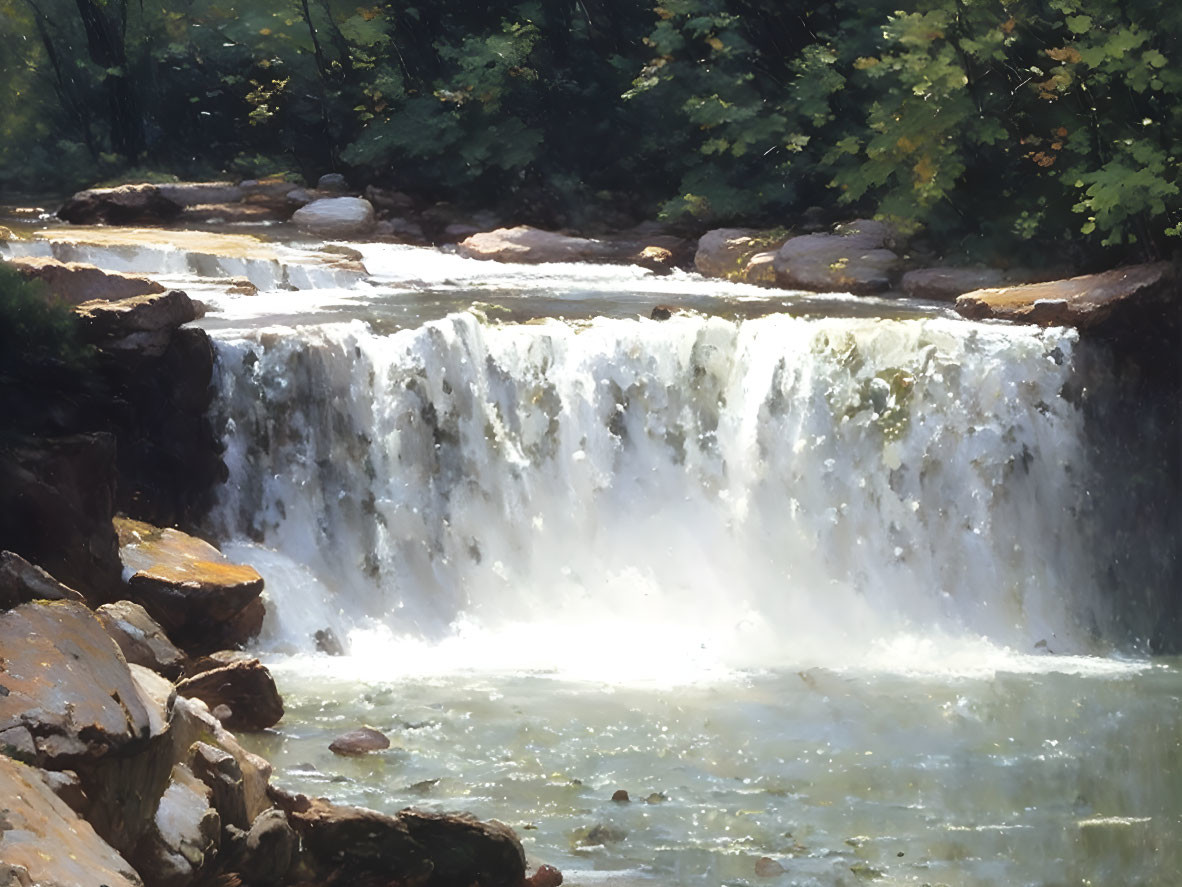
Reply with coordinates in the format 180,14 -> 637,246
0,0 -> 1182,258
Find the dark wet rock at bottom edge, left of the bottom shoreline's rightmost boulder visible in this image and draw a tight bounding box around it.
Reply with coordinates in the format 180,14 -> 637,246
272,791 -> 434,887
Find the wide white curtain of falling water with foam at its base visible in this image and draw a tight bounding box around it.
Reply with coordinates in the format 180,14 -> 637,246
205,312 -> 1105,672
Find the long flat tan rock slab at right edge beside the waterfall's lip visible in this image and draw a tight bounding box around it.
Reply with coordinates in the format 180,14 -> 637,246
956,261 -> 1178,331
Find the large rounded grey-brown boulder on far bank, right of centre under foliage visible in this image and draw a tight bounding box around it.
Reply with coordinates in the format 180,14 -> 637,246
773,220 -> 898,293
